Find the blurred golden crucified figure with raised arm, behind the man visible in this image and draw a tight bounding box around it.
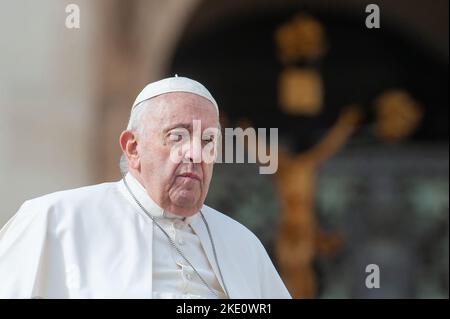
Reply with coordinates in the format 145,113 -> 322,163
275,106 -> 362,298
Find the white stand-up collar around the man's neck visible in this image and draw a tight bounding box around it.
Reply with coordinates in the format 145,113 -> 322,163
125,172 -> 197,220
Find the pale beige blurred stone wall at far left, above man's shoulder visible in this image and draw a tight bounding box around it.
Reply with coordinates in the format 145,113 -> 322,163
0,0 -> 100,226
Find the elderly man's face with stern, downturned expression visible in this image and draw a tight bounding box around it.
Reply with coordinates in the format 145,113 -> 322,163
123,92 -> 219,216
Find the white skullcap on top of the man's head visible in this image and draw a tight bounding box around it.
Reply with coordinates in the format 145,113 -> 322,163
131,74 -> 219,114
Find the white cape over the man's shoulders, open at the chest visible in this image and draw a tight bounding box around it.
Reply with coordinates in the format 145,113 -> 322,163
0,181 -> 290,298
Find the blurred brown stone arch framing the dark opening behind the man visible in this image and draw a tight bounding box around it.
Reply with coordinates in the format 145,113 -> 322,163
96,0 -> 448,181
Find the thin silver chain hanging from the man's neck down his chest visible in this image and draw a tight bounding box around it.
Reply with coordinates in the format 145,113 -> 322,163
123,176 -> 229,298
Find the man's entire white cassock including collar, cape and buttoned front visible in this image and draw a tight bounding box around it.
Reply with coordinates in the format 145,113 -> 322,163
0,174 -> 291,298
